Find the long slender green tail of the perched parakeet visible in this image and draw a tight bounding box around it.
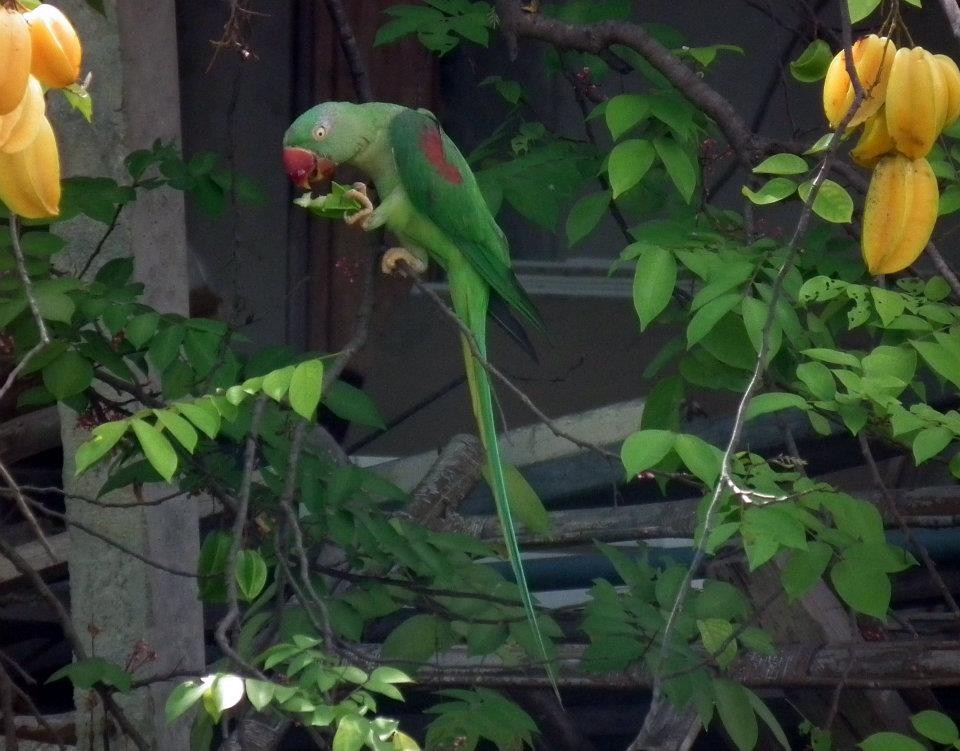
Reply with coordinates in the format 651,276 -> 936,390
451,285 -> 562,703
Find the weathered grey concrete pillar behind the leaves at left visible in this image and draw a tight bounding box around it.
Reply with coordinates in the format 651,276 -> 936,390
50,0 -> 204,751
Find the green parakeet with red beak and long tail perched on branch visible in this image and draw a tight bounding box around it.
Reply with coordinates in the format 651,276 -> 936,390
283,102 -> 556,689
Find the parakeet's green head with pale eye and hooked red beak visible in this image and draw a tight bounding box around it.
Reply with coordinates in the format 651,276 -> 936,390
283,102 -> 374,190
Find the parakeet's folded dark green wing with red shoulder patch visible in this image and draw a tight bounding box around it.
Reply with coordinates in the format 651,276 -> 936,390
390,110 -> 543,331
